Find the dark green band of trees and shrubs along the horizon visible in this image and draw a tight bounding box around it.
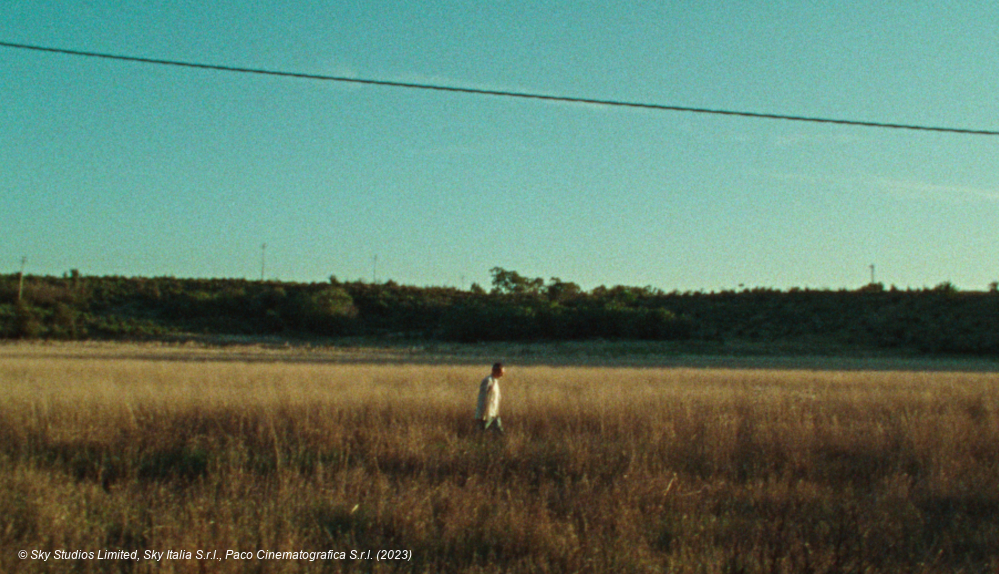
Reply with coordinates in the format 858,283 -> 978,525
0,267 -> 999,354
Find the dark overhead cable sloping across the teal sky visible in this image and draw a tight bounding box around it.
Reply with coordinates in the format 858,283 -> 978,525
0,42 -> 999,136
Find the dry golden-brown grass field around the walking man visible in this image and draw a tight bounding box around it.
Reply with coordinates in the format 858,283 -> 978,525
0,345 -> 999,573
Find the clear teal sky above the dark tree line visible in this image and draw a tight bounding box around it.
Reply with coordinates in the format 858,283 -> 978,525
0,0 -> 999,291
